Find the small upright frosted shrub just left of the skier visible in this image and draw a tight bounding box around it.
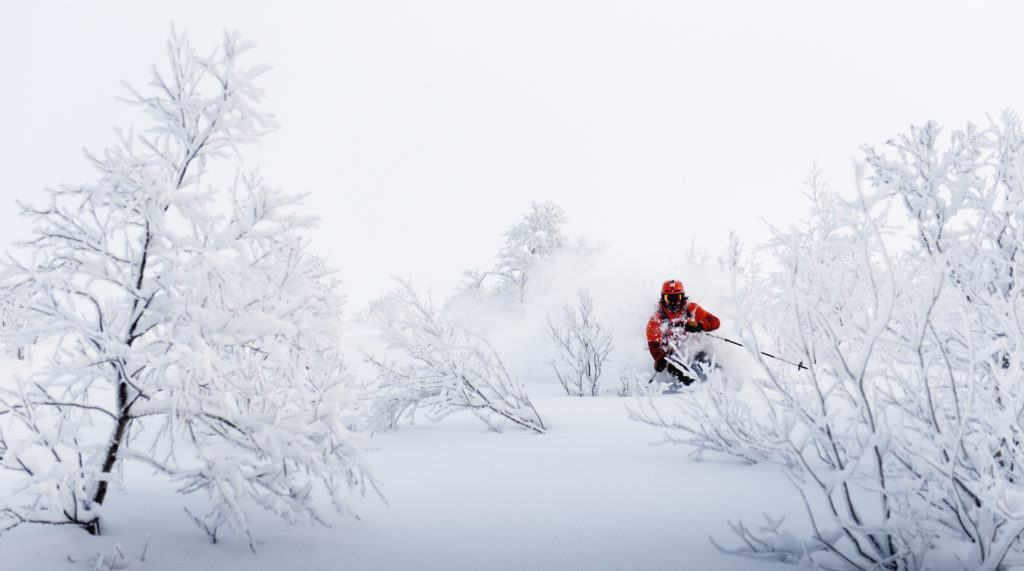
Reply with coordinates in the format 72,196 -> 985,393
548,289 -> 611,396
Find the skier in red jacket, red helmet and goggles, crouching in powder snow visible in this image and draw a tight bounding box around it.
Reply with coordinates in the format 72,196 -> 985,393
647,279 -> 721,385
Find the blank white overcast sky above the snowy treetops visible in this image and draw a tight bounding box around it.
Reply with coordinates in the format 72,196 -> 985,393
0,0 -> 1024,309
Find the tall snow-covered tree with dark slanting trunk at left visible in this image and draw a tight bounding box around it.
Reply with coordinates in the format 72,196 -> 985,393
0,32 -> 372,538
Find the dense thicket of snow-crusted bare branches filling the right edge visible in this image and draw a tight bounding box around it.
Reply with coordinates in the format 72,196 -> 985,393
642,114 -> 1024,569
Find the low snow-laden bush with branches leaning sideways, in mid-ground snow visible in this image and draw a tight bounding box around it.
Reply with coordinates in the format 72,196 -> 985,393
368,281 -> 545,433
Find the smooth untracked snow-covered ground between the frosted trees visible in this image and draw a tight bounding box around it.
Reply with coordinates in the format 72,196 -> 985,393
0,386 -> 800,570
